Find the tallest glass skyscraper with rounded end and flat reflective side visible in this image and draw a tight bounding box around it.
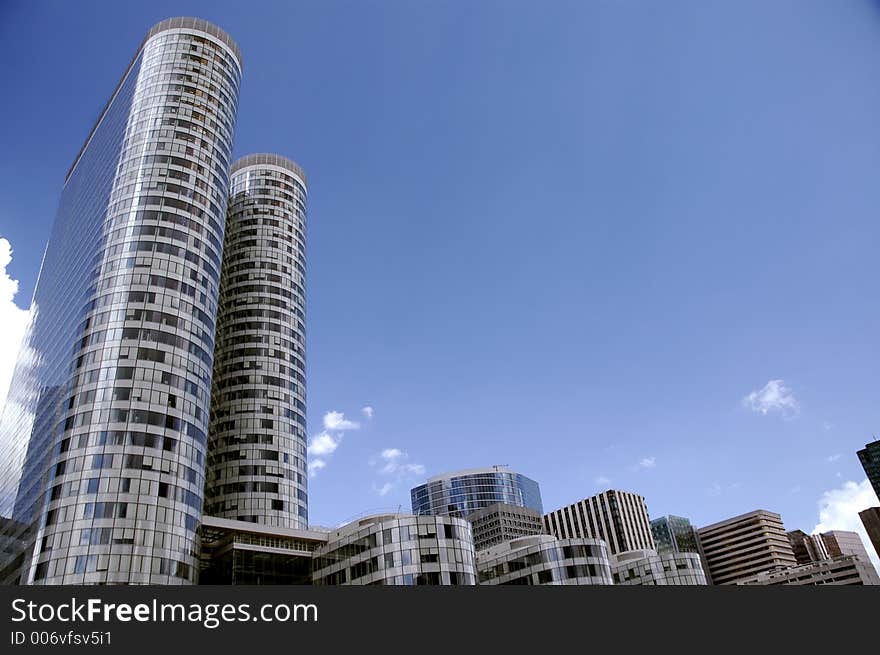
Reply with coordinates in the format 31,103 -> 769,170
0,18 -> 241,584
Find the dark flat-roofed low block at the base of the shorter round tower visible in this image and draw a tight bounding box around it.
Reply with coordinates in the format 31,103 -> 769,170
199,516 -> 328,585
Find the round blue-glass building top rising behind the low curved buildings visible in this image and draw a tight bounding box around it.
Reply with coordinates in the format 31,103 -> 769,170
410,466 -> 544,518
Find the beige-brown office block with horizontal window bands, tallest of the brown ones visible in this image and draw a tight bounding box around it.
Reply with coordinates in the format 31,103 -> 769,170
697,509 -> 797,585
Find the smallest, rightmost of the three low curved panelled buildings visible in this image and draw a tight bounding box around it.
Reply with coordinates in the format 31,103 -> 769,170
611,550 -> 708,586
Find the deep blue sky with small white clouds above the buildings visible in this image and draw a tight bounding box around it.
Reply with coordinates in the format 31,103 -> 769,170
0,0 -> 880,560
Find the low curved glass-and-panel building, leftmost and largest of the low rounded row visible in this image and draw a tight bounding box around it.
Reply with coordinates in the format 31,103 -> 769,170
312,514 -> 476,585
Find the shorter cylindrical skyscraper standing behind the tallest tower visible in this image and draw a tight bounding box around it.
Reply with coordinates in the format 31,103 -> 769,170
205,154 -> 308,528
